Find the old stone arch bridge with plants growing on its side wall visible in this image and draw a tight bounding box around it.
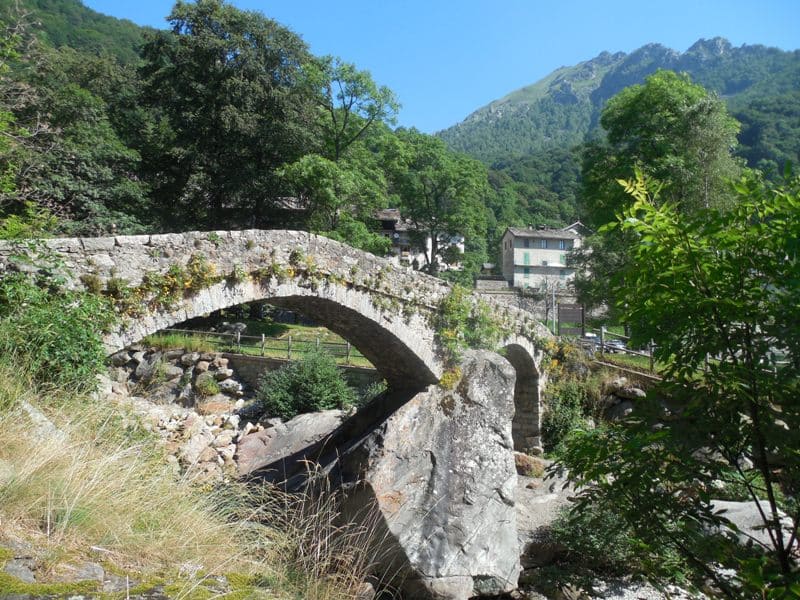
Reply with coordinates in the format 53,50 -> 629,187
0,230 -> 550,449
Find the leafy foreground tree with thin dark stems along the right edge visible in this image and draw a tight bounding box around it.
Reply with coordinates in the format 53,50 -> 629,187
564,175 -> 800,598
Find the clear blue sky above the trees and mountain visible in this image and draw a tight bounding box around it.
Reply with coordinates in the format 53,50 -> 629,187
84,0 -> 800,133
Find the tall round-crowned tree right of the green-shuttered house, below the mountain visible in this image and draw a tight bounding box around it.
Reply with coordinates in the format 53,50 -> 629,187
575,71 -> 740,312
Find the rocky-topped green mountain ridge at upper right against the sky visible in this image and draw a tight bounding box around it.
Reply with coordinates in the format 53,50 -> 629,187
437,38 -> 800,165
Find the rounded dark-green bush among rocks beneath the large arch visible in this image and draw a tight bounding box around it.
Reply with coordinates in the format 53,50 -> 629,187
258,350 -> 356,419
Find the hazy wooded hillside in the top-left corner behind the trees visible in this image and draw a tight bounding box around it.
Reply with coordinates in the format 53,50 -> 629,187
0,0 -> 149,64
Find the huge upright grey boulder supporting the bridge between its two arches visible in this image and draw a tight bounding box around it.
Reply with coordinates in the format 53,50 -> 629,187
341,351 -> 520,600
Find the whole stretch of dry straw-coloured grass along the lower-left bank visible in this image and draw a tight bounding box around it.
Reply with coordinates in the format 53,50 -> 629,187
0,364 -> 390,600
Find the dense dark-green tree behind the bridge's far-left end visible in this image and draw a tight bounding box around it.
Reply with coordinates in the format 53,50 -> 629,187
17,48 -> 149,235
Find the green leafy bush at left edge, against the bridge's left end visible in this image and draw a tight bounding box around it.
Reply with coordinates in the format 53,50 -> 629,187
0,275 -> 114,387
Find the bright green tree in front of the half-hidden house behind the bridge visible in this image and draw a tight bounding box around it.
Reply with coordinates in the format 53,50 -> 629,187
386,130 -> 489,273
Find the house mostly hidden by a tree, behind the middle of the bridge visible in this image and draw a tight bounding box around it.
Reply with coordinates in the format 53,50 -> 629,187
375,208 -> 464,270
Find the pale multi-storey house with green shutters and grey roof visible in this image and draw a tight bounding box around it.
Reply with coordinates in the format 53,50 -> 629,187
502,221 -> 587,290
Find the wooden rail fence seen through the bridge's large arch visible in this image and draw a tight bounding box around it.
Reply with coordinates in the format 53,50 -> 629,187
153,328 -> 371,366
